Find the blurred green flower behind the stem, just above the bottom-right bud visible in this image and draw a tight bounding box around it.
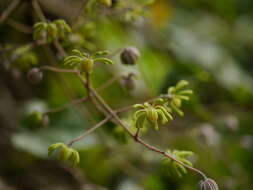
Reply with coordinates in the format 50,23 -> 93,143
163,150 -> 194,177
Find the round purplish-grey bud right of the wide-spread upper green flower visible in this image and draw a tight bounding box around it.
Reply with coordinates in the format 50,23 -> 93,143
120,47 -> 140,65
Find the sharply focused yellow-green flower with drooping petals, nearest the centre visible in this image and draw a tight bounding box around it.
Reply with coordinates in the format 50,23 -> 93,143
134,102 -> 173,130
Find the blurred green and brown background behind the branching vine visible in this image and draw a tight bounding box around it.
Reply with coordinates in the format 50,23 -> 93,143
0,0 -> 253,190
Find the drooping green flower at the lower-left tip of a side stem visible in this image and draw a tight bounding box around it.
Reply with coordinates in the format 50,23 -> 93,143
48,143 -> 80,165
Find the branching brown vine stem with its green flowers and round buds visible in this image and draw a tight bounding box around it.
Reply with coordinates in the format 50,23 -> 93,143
0,0 -> 218,190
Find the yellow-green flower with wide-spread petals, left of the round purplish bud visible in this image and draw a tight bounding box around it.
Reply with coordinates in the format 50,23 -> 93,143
63,49 -> 112,73
